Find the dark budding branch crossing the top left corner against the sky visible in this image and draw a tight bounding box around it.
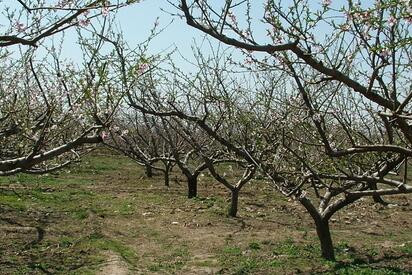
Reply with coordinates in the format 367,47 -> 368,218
0,0 -> 130,47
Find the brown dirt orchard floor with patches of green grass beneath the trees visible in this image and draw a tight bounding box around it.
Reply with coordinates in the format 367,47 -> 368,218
0,152 -> 412,274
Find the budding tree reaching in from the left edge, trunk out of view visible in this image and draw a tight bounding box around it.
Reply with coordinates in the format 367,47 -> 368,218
0,0 -> 144,176
